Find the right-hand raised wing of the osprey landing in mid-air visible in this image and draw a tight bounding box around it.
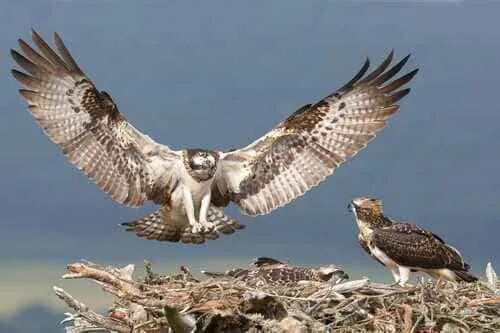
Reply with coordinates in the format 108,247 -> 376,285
212,52 -> 418,215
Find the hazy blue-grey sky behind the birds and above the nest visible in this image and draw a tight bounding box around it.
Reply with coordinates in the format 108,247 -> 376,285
0,0 -> 500,320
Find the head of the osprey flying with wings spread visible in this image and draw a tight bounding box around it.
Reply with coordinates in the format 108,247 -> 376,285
186,149 -> 219,181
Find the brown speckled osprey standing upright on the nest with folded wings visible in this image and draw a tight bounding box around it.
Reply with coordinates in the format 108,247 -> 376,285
349,197 -> 477,286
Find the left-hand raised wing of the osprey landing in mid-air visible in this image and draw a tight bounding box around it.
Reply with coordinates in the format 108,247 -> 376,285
11,31 -> 181,206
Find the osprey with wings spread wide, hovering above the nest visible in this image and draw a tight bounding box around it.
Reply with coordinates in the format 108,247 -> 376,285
11,31 -> 417,243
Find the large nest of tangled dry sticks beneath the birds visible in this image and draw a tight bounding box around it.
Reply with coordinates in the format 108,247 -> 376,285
54,261 -> 500,333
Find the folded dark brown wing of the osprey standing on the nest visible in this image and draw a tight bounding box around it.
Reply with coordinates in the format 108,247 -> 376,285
372,223 -> 467,270
